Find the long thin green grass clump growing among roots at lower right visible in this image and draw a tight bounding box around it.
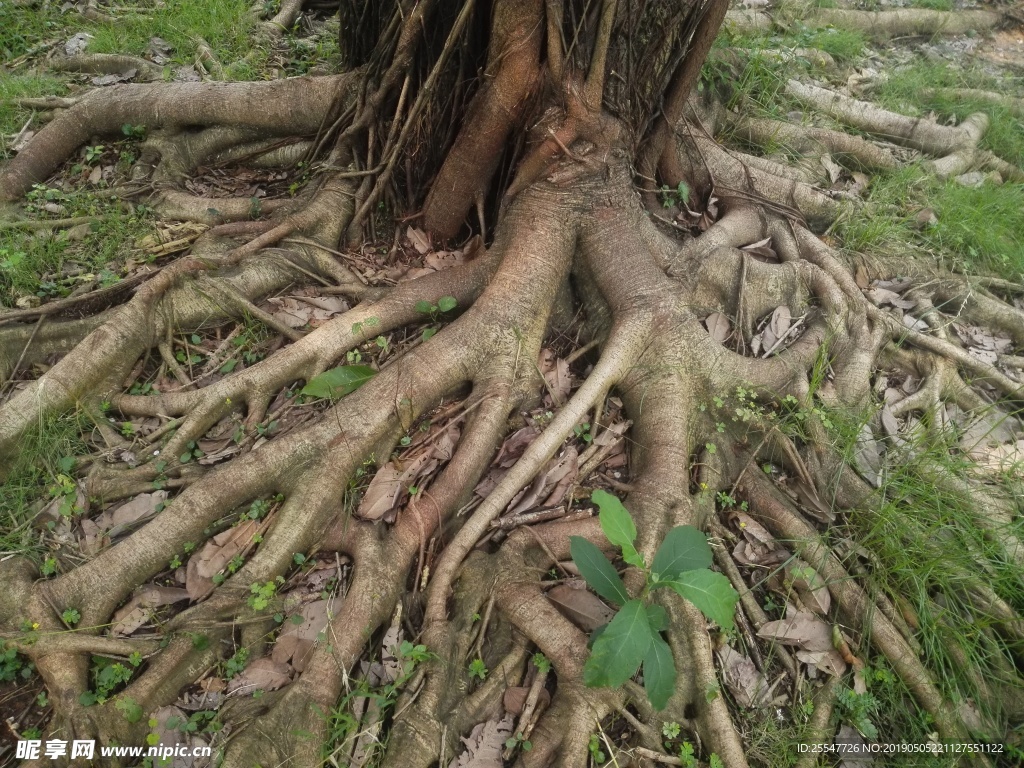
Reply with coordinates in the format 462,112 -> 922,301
829,405 -> 1024,753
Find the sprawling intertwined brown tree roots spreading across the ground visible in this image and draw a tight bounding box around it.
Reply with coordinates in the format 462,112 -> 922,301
0,3 -> 1024,768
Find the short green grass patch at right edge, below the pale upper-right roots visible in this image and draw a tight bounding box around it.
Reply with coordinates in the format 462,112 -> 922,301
837,167 -> 1024,280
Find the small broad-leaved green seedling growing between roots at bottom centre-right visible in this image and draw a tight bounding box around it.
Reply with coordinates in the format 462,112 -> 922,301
569,490 -> 739,710
